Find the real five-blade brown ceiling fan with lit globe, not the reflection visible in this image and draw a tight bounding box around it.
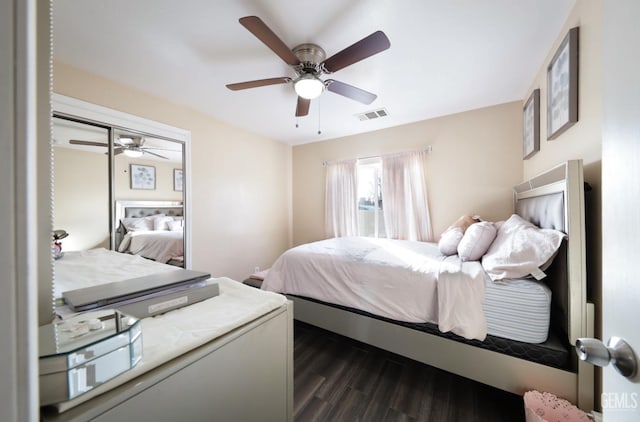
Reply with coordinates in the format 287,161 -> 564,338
227,16 -> 391,117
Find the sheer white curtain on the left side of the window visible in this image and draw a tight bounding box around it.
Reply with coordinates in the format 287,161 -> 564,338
324,160 -> 358,237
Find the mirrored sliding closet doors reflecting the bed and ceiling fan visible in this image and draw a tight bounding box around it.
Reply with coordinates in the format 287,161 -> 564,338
52,105 -> 188,299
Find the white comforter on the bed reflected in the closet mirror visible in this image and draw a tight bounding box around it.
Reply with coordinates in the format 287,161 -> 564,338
118,230 -> 184,263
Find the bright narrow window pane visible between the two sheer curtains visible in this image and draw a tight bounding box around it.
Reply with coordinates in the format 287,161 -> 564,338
357,157 -> 386,237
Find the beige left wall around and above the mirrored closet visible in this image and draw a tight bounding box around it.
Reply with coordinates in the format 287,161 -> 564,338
53,62 -> 291,280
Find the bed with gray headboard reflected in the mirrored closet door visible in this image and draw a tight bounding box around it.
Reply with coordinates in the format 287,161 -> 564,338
114,201 -> 184,267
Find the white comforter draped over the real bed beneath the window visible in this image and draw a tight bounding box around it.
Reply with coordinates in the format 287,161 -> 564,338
262,237 -> 487,340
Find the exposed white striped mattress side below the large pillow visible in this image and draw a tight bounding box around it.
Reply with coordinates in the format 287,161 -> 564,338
483,279 -> 551,343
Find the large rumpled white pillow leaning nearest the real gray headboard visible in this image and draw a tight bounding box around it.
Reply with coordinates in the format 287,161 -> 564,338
482,214 -> 565,281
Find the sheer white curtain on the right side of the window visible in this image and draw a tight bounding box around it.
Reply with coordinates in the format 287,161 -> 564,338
382,152 -> 433,241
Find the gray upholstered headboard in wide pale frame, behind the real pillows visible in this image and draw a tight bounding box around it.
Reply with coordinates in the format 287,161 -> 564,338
514,160 -> 589,344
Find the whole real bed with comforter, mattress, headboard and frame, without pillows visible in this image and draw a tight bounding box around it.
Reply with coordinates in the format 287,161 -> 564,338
262,160 -> 594,410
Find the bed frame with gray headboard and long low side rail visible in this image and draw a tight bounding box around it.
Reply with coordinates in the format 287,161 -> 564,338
290,160 -> 594,411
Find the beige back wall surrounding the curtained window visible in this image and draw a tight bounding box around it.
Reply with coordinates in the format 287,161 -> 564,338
293,101 -> 522,245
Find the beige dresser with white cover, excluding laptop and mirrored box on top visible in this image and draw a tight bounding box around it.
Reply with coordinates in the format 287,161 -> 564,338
46,249 -> 293,421
